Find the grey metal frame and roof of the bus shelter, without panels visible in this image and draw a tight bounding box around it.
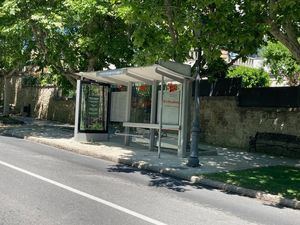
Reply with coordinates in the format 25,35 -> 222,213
74,62 -> 193,157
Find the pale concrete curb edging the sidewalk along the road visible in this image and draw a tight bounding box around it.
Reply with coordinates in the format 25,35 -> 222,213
4,133 -> 300,209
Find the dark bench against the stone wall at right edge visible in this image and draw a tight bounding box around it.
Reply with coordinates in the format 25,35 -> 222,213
249,132 -> 300,158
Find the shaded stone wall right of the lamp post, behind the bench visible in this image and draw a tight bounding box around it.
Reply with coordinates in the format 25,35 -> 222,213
200,97 -> 300,148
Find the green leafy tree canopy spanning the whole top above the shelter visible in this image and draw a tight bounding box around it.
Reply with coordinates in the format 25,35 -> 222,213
0,0 -> 300,78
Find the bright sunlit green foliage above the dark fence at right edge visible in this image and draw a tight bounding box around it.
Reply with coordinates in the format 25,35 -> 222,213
261,42 -> 300,85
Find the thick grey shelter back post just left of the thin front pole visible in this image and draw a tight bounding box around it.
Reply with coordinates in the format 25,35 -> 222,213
149,81 -> 157,151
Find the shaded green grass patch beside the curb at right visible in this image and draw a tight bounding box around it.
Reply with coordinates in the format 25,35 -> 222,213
205,166 -> 300,200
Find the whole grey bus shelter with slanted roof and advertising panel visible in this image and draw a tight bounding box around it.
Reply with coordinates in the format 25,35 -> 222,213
74,62 -> 193,157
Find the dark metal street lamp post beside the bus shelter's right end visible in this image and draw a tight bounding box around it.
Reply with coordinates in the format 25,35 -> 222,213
187,50 -> 201,167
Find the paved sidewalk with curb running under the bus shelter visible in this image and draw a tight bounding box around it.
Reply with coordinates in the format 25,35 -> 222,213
0,118 -> 300,208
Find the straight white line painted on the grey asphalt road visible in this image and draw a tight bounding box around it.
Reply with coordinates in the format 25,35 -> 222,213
0,160 -> 167,225
